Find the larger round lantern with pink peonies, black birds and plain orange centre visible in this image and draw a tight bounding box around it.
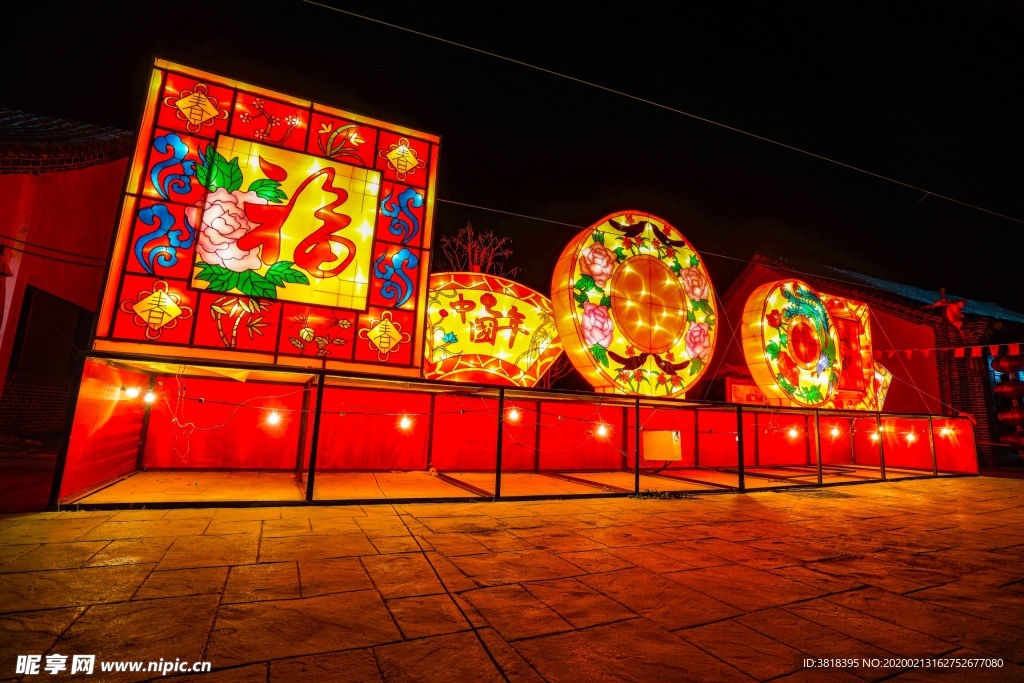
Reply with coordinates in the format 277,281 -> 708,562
551,211 -> 718,396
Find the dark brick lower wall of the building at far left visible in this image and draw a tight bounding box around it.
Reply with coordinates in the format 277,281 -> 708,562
0,373 -> 72,436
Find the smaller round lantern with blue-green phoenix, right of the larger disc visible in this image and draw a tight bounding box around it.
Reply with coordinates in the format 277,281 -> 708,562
742,280 -> 842,408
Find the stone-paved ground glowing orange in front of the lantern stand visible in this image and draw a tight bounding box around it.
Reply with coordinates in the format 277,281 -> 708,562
0,478 -> 1024,683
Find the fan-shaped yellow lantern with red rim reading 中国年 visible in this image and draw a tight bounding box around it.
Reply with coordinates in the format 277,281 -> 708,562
423,272 -> 562,387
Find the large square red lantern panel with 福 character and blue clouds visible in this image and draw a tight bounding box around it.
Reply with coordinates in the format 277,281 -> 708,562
95,60 -> 438,376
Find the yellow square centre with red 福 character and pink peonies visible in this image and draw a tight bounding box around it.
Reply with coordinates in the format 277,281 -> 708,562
190,136 -> 380,309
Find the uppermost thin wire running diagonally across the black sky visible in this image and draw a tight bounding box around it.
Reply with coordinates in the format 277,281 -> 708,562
303,0 -> 1024,224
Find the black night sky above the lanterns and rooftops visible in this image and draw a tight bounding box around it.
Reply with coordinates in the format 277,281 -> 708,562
0,0 -> 1024,311
